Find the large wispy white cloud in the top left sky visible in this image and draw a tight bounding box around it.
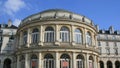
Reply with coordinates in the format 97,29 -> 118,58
4,0 -> 26,15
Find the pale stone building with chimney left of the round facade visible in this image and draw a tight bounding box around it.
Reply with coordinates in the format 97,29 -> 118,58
0,20 -> 17,68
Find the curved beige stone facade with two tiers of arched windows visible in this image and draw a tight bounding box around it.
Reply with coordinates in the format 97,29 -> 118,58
16,9 -> 99,68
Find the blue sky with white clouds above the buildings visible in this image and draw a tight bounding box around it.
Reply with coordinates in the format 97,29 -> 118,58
0,0 -> 120,30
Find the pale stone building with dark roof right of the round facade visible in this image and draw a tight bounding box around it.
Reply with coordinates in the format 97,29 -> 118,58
97,26 -> 120,68
